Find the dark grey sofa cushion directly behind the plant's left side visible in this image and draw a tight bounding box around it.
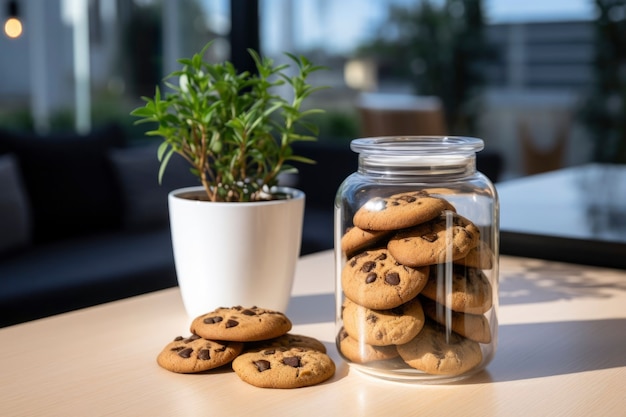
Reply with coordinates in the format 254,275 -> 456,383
110,143 -> 198,230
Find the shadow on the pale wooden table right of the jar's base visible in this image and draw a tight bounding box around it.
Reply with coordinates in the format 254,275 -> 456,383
462,319 -> 626,384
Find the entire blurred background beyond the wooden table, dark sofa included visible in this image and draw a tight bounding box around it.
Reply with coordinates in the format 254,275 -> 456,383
0,0 -> 626,327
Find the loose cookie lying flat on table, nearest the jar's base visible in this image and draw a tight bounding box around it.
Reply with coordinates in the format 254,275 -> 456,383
232,347 -> 335,388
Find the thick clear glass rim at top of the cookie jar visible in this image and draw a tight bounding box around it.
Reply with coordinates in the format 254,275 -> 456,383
350,136 -> 484,156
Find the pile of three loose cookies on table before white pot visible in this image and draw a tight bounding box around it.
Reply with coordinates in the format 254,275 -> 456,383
157,306 -> 335,388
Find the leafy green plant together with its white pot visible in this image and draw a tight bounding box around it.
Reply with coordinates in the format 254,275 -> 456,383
131,44 -> 321,317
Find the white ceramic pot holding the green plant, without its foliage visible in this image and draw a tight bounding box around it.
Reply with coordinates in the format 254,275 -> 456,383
168,187 -> 305,318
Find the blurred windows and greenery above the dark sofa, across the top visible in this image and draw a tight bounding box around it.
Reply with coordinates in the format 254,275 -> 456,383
0,0 -> 626,179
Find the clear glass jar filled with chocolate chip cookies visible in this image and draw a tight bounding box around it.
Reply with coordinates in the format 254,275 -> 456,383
335,136 -> 499,382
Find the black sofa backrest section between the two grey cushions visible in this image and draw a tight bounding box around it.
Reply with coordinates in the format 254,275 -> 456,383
0,126 -> 125,242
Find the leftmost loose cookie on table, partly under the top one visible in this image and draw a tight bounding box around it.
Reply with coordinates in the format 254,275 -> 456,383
157,334 -> 243,374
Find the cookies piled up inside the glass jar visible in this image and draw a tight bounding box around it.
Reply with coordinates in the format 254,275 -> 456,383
337,191 -> 494,376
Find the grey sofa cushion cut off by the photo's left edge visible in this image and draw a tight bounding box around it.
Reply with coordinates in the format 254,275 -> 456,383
0,154 -> 31,256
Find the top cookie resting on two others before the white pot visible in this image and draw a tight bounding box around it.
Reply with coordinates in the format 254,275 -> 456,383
191,306 -> 291,342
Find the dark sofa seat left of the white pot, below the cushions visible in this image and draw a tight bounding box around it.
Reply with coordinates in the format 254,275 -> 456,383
0,228 -> 176,327
